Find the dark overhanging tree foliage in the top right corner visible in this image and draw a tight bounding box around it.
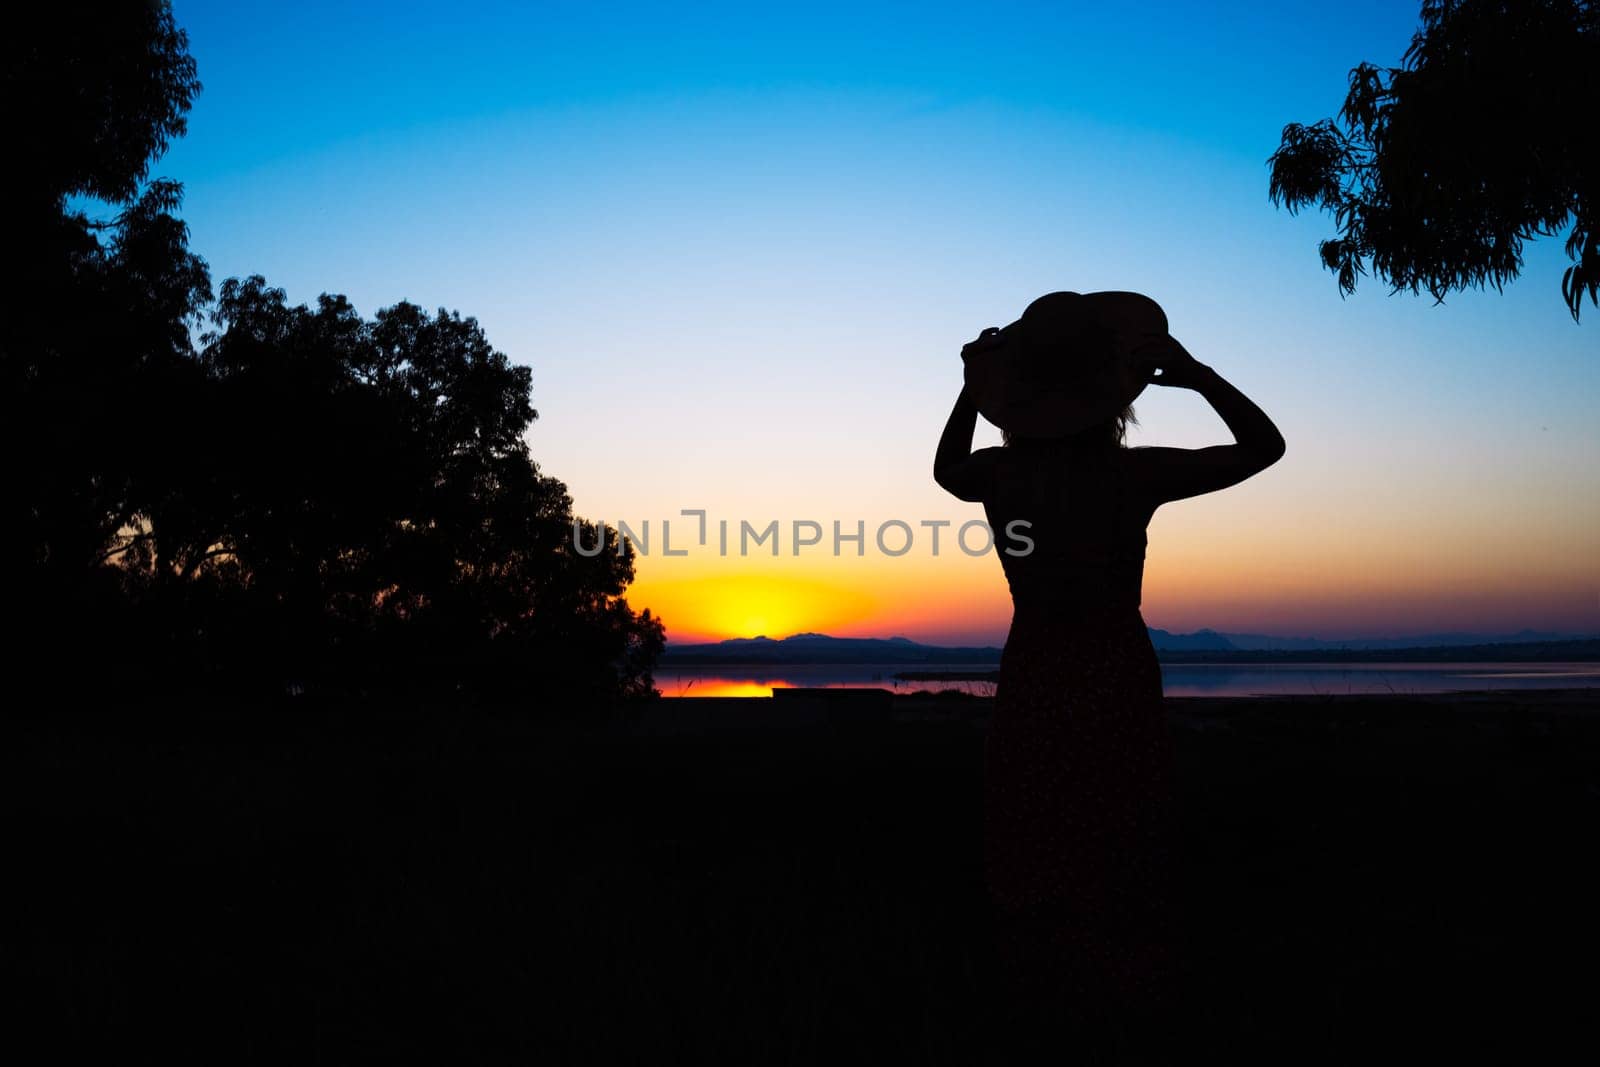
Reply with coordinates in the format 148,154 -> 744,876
1269,0 -> 1600,320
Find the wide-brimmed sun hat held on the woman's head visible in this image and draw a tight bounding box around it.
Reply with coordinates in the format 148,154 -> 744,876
962,293 -> 1166,437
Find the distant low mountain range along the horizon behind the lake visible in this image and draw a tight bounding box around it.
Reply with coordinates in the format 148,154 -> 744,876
661,627 -> 1600,667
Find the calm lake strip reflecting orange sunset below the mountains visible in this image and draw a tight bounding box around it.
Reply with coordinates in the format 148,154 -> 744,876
656,662 -> 1600,696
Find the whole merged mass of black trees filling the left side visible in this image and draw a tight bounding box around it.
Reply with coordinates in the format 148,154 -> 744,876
0,3 -> 664,709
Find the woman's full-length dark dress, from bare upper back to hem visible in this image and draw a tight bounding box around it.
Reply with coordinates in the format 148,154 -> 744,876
984,445 -> 1176,1049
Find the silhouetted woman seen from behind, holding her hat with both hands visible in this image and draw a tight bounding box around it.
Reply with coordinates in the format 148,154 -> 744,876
934,293 -> 1283,1040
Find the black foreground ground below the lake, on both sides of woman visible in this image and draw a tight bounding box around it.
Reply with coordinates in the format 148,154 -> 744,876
0,691 -> 1600,1064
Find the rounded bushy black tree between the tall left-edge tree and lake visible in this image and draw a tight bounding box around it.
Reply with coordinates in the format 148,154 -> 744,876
103,277 -> 664,699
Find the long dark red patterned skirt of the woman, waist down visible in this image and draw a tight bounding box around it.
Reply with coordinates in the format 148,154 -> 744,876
984,606 -> 1178,1036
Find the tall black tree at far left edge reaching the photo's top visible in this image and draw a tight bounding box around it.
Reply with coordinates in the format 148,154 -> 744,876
0,3 -> 210,668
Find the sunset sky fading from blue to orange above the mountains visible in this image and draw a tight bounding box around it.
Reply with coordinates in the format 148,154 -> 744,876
165,0 -> 1600,643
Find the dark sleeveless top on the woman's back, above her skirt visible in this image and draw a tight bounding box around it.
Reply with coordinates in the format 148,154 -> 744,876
984,442 -> 1155,614
